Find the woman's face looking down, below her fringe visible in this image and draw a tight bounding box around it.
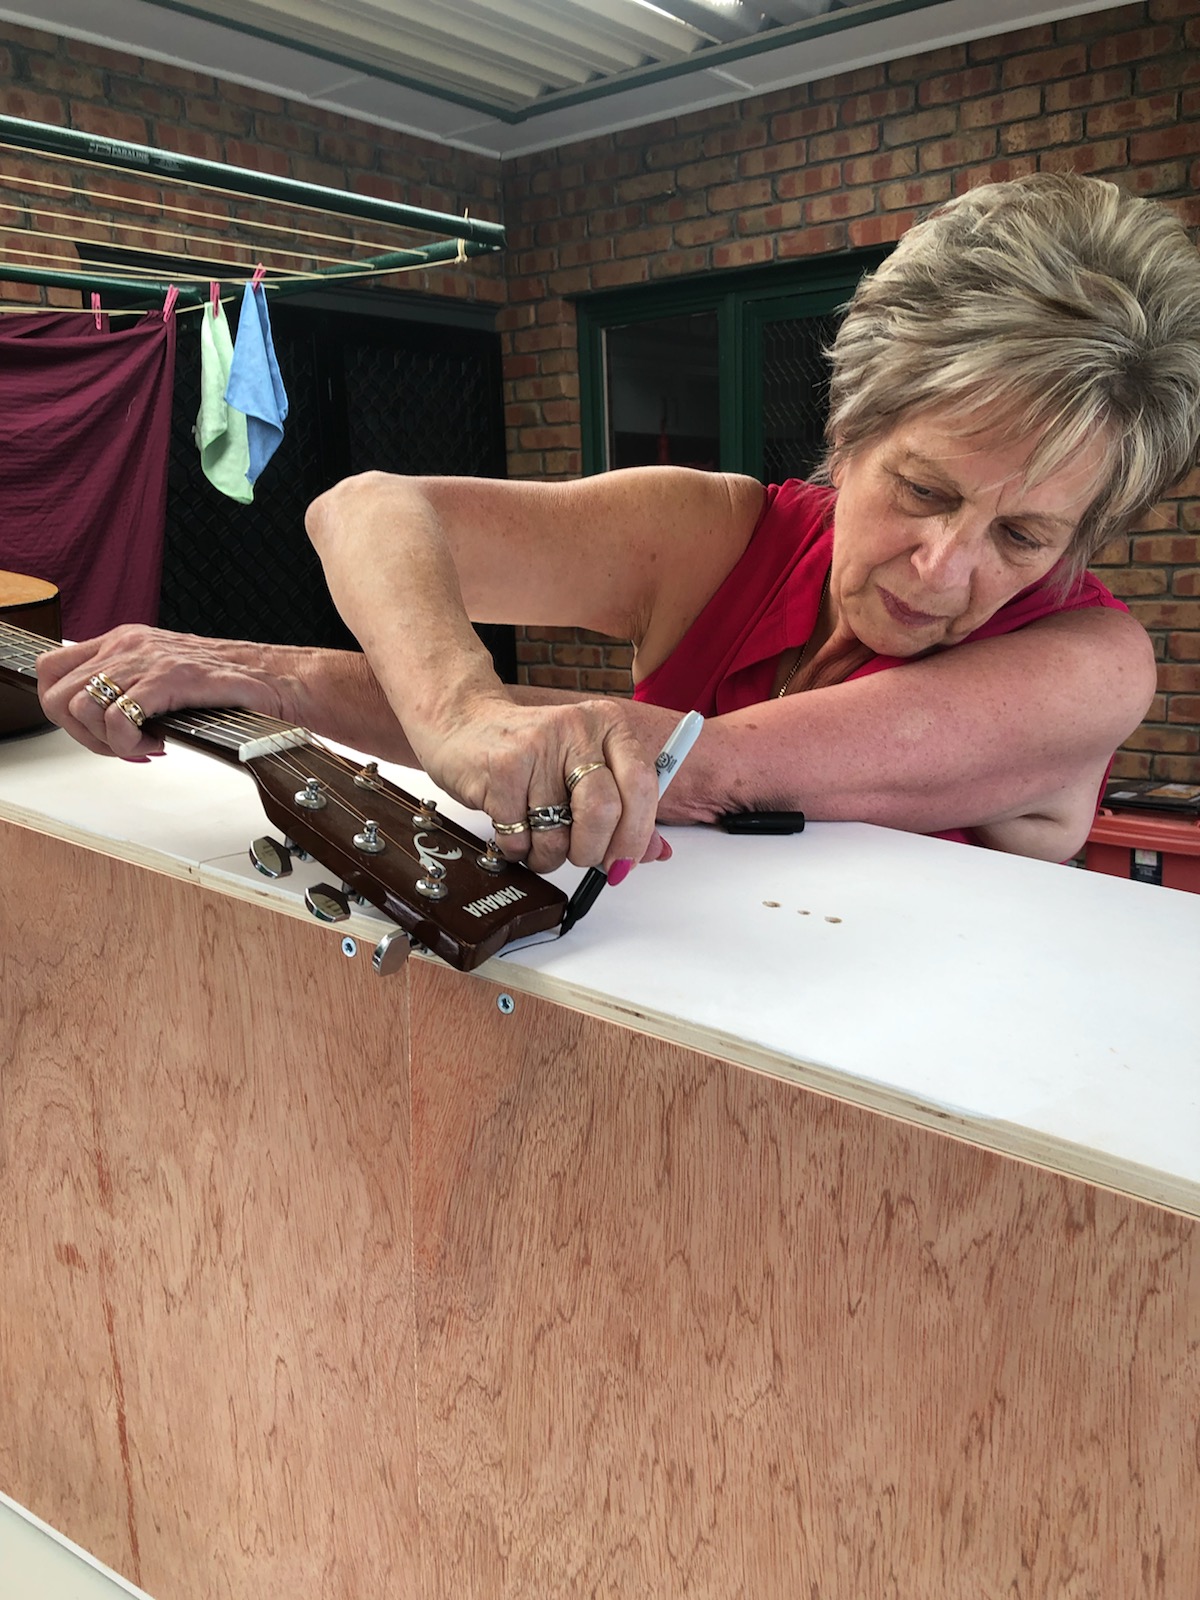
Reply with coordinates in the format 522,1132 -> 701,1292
830,413 -> 1106,656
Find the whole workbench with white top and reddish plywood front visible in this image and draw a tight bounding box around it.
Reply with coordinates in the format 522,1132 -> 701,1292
0,733 -> 1200,1600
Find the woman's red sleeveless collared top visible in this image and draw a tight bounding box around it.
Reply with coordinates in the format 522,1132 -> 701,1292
634,478 -> 1128,843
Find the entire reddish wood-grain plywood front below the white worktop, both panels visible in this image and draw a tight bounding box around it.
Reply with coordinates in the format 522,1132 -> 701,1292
0,824 -> 1200,1600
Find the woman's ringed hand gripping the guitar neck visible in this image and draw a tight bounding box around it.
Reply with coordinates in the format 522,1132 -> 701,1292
37,624 -> 286,762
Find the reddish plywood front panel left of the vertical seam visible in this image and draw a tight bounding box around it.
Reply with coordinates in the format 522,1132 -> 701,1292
0,826 -> 419,1600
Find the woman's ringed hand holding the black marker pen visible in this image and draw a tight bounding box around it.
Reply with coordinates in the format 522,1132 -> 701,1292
416,685 -> 667,872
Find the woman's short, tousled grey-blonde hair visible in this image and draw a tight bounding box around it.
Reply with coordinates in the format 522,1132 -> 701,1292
826,173 -> 1200,579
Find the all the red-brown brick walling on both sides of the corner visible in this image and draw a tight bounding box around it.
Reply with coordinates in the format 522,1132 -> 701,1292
0,0 -> 1200,781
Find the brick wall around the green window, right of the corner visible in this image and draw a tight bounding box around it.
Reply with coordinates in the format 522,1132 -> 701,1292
501,0 -> 1200,782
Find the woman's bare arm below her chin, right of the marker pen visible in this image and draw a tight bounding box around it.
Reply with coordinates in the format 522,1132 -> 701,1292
611,608 -> 1155,861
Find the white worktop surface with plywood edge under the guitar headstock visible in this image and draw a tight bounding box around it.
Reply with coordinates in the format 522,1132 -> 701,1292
0,731 -> 1200,1216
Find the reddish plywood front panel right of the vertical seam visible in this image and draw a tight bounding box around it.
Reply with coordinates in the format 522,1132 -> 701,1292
413,966 -> 1200,1600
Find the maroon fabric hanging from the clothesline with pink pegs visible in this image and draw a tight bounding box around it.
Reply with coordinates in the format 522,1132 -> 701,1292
0,312 -> 174,638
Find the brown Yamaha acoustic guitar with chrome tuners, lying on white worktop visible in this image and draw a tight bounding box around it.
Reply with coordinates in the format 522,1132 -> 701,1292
0,574 -> 566,973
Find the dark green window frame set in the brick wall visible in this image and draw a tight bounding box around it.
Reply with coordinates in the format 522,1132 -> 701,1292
574,250 -> 888,478
